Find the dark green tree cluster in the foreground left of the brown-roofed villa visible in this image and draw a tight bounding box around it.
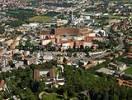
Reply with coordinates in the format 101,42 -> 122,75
0,68 -> 45,100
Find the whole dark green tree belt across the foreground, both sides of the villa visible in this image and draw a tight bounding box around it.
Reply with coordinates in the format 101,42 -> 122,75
0,61 -> 132,100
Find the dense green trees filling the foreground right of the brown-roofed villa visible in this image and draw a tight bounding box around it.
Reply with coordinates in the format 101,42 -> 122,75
56,66 -> 132,100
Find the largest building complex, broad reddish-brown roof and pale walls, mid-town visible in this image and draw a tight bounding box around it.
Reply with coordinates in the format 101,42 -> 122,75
55,27 -> 95,49
